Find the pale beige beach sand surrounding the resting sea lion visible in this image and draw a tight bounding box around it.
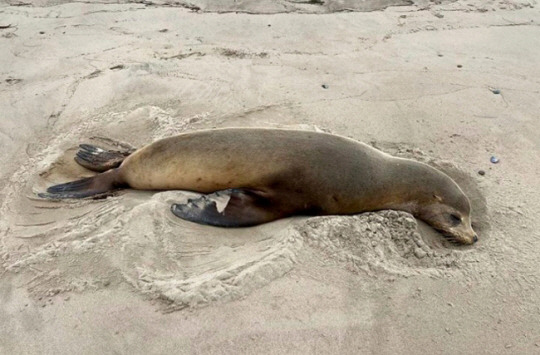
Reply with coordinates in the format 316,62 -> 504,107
0,0 -> 540,354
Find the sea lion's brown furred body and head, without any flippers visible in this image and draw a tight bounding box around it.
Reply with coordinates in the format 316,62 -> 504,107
46,128 -> 477,244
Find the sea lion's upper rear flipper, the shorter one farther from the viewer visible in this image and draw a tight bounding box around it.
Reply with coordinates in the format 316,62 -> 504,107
75,144 -> 133,172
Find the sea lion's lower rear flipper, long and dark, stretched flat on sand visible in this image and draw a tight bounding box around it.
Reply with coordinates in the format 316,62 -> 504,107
39,169 -> 120,199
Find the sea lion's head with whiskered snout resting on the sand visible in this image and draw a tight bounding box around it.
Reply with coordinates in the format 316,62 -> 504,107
418,183 -> 478,245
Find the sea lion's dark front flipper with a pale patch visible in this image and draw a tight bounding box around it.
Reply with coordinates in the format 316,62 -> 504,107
171,189 -> 284,227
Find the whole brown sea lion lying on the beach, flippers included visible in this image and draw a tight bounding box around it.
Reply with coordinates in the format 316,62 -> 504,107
42,128 -> 478,244
